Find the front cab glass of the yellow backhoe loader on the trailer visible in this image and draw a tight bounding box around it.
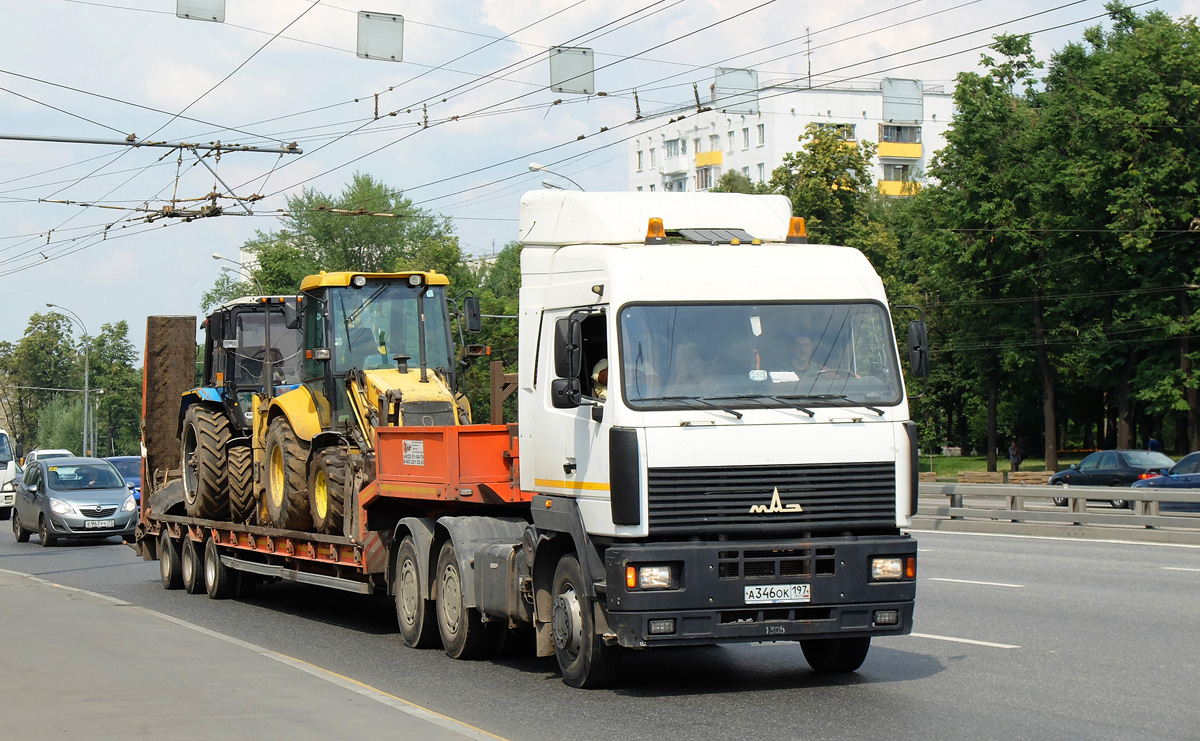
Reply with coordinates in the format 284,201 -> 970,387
329,279 -> 454,373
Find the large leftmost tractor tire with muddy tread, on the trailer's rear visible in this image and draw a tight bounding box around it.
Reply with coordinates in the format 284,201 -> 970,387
179,404 -> 229,519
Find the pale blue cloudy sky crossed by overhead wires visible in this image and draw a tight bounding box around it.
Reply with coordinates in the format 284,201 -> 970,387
0,0 -> 1200,355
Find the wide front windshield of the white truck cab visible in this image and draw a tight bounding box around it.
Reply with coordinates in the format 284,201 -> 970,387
618,302 -> 902,409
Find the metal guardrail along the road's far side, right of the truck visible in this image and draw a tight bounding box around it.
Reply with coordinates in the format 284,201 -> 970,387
912,483 -> 1200,544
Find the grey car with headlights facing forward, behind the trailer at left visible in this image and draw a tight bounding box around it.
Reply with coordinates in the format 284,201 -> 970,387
12,457 -> 138,546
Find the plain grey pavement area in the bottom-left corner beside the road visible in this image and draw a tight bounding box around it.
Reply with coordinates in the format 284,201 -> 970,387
0,571 -> 498,741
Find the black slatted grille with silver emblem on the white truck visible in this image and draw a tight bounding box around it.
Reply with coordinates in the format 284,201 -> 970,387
648,462 -> 895,535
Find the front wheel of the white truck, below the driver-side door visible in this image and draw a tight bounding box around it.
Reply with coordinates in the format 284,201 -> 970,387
551,554 -> 619,689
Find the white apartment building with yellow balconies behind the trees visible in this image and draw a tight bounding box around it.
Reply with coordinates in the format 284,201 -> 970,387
629,78 -> 954,195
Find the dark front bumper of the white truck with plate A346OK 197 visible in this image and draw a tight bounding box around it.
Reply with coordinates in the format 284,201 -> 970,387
605,536 -> 917,647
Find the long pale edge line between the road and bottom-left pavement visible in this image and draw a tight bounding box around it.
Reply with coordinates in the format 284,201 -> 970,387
0,568 -> 508,741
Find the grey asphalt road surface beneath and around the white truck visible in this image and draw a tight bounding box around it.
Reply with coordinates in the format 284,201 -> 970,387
0,523 -> 1200,741
